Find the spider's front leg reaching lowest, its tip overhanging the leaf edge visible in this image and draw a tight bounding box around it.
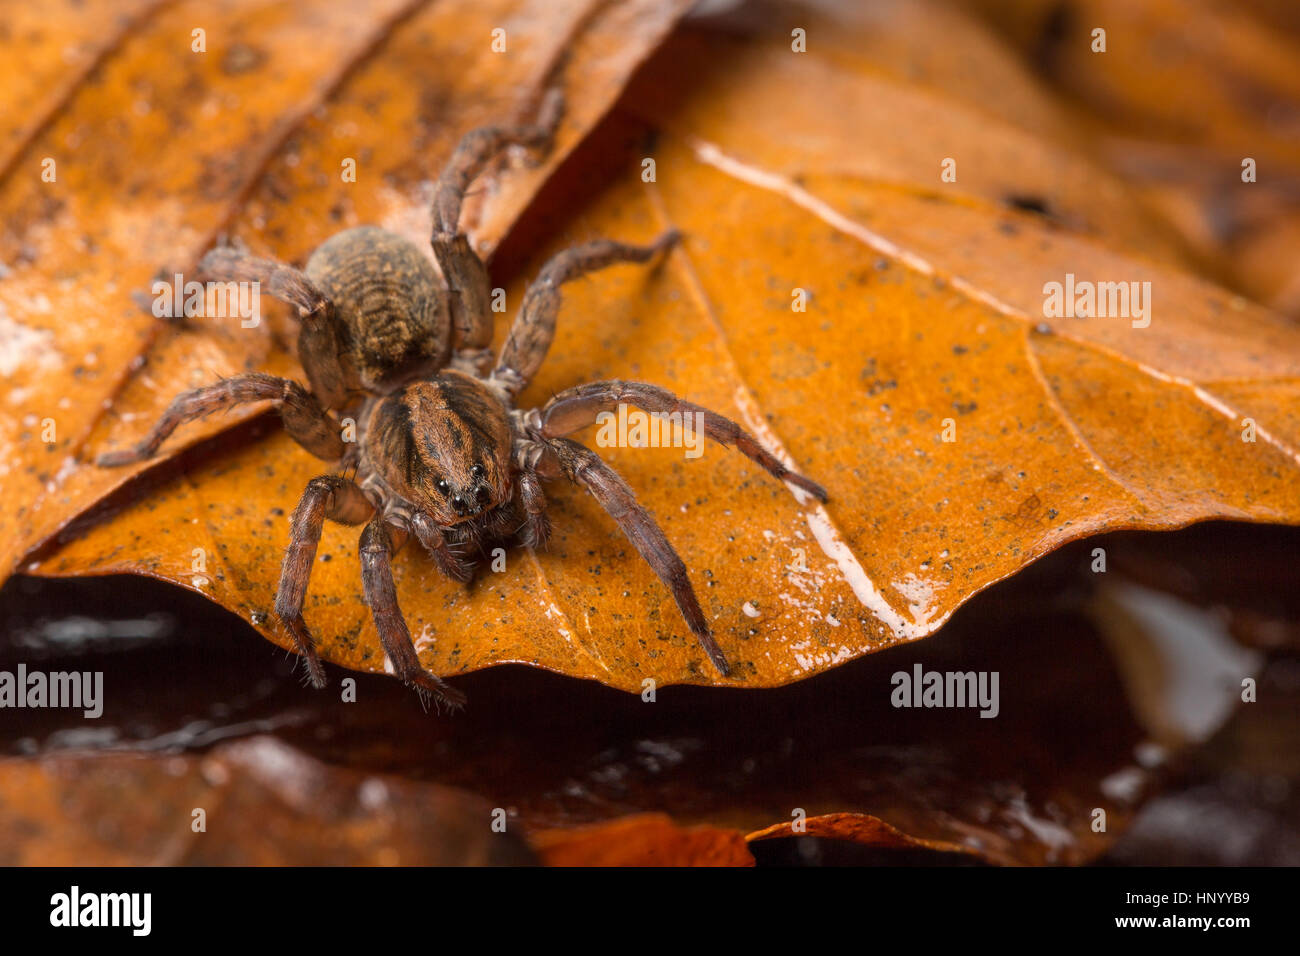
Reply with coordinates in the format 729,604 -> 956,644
360,516 -> 465,710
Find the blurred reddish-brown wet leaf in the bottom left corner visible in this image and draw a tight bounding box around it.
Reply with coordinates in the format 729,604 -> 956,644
0,736 -> 536,866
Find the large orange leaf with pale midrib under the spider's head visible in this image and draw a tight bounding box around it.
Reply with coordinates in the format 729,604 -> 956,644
22,0 -> 1300,691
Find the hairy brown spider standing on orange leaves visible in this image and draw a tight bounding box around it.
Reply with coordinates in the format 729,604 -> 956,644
98,90 -> 827,709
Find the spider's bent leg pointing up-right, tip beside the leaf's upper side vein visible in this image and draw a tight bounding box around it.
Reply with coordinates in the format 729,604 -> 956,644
491,229 -> 681,395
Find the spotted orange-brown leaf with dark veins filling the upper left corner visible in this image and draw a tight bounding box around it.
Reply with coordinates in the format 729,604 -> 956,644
0,0 -> 686,575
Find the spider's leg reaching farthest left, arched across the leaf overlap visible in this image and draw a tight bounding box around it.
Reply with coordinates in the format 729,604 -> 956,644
96,372 -> 346,468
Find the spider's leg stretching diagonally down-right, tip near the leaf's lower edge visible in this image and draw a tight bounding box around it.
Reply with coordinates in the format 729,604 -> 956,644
546,438 -> 731,676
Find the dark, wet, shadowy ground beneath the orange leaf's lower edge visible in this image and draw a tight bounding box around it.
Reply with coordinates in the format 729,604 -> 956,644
0,524 -> 1300,865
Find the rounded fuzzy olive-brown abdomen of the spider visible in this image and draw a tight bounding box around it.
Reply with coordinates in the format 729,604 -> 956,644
304,226 -> 451,394
